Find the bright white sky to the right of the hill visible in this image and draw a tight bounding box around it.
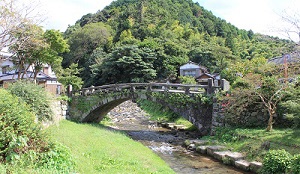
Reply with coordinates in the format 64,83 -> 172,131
196,0 -> 300,40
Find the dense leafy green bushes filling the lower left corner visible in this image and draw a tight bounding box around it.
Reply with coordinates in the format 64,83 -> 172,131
0,89 -> 73,173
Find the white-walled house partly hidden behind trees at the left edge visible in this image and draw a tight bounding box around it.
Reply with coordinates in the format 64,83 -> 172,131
0,51 -> 62,94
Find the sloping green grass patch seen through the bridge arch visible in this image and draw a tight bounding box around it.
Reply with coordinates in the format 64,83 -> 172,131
138,100 -> 196,130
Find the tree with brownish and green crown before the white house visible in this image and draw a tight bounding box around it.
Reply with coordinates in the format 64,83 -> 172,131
9,25 -> 68,80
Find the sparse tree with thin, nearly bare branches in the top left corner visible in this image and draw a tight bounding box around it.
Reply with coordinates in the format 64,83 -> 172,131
0,0 -> 42,50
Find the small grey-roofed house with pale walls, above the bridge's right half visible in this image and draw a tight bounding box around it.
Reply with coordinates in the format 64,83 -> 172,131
180,61 -> 207,78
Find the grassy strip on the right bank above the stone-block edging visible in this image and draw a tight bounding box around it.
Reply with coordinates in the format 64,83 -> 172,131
203,128 -> 300,161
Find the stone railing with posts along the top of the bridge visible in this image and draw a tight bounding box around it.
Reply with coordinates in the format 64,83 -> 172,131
69,79 -> 230,95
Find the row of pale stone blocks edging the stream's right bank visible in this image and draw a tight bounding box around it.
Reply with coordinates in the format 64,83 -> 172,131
185,140 -> 262,173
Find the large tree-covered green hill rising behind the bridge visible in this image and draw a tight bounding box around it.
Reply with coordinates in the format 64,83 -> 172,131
63,0 -> 294,86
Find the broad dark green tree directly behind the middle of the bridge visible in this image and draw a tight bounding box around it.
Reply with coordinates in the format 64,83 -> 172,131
102,45 -> 156,83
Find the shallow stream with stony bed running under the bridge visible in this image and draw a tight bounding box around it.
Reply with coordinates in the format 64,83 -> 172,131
108,101 -> 250,174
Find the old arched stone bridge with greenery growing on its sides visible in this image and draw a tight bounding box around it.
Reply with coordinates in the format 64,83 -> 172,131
68,79 -> 229,135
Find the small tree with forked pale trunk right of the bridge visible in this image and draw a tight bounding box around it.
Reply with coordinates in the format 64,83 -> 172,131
228,61 -> 288,131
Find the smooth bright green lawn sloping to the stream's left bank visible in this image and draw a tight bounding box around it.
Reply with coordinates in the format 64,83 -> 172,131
47,120 -> 174,174
